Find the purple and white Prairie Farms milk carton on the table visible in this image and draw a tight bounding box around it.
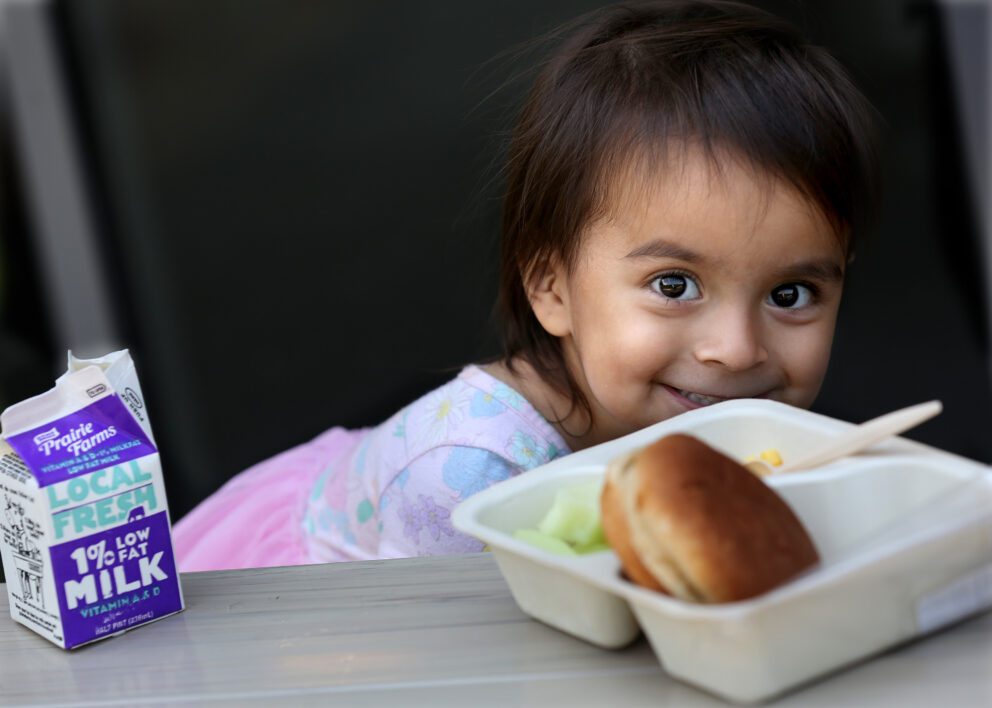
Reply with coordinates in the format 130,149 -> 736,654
0,350 -> 183,649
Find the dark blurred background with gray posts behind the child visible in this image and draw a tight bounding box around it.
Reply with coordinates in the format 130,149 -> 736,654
0,0 -> 992,580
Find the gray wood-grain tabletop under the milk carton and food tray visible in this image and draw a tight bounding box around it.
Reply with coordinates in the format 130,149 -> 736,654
0,554 -> 992,708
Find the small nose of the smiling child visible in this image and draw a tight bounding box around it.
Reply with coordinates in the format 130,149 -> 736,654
694,306 -> 768,371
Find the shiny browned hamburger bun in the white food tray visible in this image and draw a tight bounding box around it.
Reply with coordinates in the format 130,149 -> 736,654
601,434 -> 819,603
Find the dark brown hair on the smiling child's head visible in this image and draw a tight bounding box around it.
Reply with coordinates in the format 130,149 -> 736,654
497,0 -> 878,432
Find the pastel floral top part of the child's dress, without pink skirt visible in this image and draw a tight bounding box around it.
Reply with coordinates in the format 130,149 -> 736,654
301,367 -> 568,561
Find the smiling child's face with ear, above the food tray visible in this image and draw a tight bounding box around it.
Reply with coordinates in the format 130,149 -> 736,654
532,156 -> 845,444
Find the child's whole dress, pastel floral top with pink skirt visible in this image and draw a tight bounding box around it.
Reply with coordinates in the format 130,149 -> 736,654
173,366 -> 568,571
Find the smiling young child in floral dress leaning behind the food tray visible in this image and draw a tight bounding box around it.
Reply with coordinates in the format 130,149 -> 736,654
175,1 -> 876,571
